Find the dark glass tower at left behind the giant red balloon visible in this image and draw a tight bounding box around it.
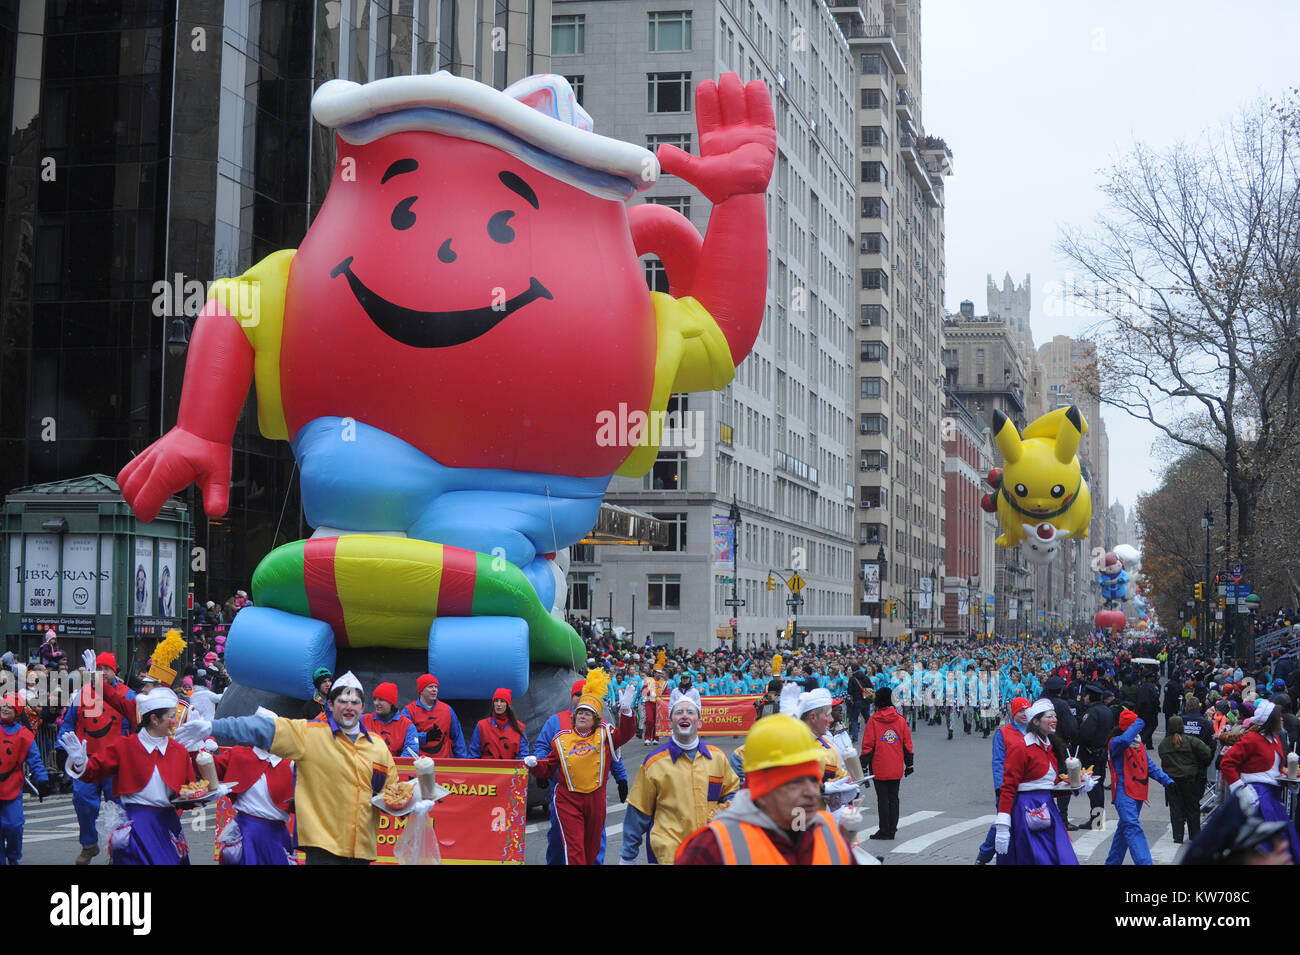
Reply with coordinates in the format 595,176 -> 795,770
0,0 -> 550,613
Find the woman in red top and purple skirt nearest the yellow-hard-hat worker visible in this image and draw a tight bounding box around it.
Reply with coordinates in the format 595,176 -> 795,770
993,699 -> 1079,865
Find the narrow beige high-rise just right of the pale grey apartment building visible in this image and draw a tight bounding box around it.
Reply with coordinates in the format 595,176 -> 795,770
832,0 -> 953,638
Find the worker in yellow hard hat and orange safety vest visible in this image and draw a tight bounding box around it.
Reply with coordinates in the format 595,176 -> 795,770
675,713 -> 857,865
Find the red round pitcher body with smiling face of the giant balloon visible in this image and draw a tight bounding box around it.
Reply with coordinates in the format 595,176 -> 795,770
281,131 -> 655,476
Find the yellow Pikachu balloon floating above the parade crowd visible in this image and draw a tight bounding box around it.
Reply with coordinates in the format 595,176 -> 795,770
980,405 -> 1092,560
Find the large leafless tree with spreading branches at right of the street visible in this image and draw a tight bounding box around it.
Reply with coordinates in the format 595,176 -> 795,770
1058,91 -> 1300,582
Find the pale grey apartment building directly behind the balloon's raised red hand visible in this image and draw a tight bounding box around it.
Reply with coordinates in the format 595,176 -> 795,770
551,0 -> 865,647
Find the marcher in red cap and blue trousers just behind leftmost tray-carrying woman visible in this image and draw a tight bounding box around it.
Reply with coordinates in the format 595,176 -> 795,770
59,650 -> 135,865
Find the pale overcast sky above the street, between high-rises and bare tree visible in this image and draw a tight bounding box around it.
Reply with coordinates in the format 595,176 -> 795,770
922,0 -> 1300,519
